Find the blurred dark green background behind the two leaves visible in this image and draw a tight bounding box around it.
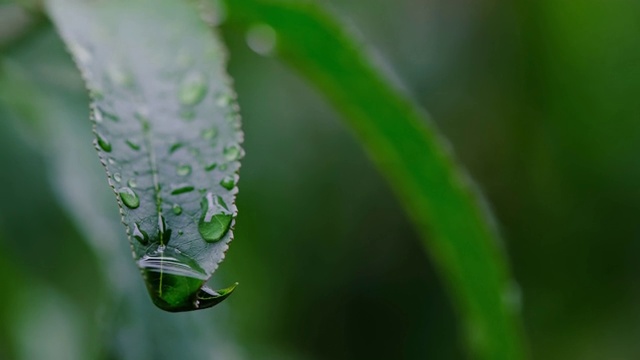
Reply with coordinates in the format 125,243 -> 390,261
0,0 -> 640,359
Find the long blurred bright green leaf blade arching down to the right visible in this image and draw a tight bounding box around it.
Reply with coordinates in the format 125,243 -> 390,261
226,0 -> 526,360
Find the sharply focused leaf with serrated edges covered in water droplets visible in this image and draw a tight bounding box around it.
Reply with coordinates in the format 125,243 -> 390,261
47,0 -> 243,311
